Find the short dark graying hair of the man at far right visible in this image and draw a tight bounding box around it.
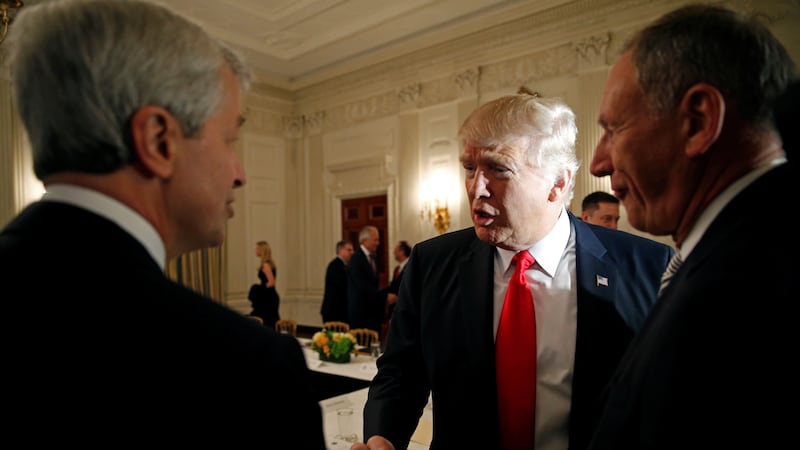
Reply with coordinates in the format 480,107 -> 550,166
623,5 -> 795,123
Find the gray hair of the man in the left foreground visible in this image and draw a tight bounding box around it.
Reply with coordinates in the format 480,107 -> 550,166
7,0 -> 251,178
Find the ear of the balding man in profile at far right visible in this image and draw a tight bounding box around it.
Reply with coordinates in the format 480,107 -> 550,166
680,83 -> 725,158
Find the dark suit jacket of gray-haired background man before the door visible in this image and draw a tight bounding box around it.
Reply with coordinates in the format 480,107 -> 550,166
347,246 -> 386,333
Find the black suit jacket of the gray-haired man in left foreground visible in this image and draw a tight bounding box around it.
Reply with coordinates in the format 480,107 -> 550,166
0,201 -> 325,449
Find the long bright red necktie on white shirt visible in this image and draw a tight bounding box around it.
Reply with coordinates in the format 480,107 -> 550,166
495,250 -> 536,450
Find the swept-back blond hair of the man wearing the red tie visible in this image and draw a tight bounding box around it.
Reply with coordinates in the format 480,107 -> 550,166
458,93 -> 580,204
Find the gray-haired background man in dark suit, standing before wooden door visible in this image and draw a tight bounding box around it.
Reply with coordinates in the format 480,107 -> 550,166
347,225 -> 387,333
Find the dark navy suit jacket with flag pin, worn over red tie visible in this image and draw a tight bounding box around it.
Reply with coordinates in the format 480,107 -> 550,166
364,214 -> 673,450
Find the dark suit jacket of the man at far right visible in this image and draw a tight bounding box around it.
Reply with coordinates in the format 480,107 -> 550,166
591,164 -> 800,450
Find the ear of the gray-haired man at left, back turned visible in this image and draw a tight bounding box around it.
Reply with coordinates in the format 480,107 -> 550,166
131,105 -> 180,179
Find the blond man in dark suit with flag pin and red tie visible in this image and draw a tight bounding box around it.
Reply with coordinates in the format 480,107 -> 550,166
354,93 -> 672,450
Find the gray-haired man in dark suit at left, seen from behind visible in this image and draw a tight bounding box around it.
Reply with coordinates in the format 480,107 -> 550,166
0,0 -> 325,449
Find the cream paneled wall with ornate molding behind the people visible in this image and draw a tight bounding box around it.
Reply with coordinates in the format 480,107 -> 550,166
0,0 -> 800,325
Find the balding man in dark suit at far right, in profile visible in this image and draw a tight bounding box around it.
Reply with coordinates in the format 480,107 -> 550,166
590,5 -> 800,450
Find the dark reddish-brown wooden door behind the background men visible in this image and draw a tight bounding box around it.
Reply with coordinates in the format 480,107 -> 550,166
342,194 -> 392,287
